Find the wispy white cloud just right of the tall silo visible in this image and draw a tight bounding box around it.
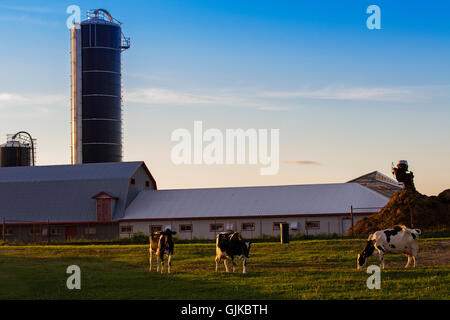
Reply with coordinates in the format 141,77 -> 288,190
124,88 -> 290,111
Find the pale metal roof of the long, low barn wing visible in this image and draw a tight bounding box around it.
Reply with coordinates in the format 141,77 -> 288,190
122,183 -> 389,220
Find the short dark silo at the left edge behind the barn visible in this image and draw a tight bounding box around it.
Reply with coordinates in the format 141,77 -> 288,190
0,141 -> 32,167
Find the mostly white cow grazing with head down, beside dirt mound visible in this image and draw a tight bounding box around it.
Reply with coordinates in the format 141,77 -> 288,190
357,225 -> 422,269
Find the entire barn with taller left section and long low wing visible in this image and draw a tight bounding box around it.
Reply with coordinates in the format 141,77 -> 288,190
0,162 -> 401,241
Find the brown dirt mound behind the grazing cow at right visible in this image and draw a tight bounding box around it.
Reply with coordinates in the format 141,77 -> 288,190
346,189 -> 450,236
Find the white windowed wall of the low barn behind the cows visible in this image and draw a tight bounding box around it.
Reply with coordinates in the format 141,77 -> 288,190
120,215 -> 367,239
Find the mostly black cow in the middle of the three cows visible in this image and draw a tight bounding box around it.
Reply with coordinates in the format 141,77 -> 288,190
216,231 -> 250,274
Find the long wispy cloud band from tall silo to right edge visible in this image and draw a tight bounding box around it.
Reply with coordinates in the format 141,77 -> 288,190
124,86 -> 448,111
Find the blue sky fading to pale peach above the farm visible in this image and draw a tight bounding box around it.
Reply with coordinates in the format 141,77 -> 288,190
0,0 -> 450,194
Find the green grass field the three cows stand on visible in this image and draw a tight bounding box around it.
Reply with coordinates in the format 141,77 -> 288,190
0,238 -> 450,299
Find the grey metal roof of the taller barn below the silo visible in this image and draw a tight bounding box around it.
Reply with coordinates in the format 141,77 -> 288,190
0,162 -> 148,223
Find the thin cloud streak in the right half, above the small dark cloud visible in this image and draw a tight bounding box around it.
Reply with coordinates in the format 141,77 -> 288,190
262,87 -> 426,102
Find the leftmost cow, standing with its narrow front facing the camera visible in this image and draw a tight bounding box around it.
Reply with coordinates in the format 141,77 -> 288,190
148,229 -> 176,273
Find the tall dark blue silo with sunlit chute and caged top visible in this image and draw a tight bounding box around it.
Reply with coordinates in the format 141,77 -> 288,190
71,9 -> 129,164
